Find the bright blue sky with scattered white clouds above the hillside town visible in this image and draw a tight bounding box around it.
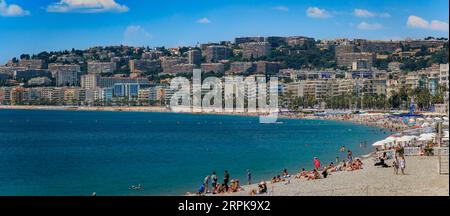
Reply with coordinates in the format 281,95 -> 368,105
0,0 -> 449,63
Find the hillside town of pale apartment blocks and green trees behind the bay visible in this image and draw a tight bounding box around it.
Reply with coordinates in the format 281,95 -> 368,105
0,36 -> 449,112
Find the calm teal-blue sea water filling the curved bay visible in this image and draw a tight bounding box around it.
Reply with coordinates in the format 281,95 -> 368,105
0,110 -> 388,196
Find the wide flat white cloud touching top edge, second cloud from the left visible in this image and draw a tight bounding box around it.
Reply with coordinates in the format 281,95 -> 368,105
47,0 -> 129,13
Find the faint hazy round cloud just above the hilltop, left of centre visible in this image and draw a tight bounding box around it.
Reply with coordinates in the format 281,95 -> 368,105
123,25 -> 152,46
